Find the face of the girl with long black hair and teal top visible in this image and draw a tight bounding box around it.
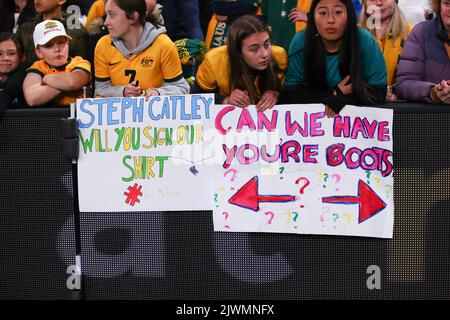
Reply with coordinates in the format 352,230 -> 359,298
314,0 -> 347,50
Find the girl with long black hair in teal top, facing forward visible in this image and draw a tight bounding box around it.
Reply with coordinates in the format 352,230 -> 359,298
282,0 -> 386,116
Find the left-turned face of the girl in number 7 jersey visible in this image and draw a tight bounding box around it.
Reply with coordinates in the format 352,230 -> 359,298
105,0 -> 133,39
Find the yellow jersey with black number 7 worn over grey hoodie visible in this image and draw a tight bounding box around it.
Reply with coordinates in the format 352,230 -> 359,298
94,34 -> 183,90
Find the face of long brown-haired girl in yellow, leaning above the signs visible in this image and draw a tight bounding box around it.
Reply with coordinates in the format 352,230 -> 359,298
241,32 -> 272,70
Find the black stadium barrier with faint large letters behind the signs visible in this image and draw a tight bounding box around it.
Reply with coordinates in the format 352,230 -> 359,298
0,103 -> 450,300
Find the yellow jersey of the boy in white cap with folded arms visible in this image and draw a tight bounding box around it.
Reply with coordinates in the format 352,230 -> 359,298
26,56 -> 91,106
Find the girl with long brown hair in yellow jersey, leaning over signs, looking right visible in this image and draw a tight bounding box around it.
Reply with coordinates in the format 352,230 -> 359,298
193,15 -> 287,111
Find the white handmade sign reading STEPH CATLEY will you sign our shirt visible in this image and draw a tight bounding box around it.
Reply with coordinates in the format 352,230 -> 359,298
76,95 -> 214,212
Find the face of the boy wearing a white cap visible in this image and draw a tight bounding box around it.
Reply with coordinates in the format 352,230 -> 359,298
36,36 -> 69,67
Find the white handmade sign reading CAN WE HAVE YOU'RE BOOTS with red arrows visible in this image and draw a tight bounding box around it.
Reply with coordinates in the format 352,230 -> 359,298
213,105 -> 394,238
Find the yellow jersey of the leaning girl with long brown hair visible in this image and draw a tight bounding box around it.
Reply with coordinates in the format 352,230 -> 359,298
196,45 -> 288,96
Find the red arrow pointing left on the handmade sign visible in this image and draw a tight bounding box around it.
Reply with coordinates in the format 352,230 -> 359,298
228,176 -> 297,211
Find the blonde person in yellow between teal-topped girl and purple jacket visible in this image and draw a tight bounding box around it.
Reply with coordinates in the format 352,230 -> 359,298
360,0 -> 413,101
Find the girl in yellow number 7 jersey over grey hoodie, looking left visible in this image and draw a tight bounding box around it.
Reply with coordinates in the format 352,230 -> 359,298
94,0 -> 189,97
